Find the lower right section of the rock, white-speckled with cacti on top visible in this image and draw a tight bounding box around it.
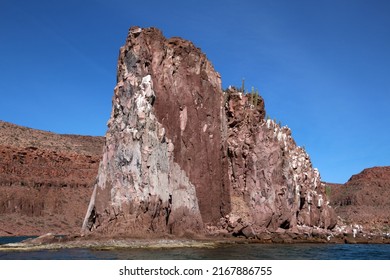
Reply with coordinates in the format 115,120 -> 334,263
222,89 -> 336,235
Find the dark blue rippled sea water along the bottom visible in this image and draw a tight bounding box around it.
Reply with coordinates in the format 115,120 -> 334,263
0,237 -> 390,260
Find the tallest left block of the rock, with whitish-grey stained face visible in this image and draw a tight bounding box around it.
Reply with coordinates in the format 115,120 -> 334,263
83,28 -> 213,235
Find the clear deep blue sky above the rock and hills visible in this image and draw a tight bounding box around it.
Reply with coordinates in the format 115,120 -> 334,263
0,0 -> 390,183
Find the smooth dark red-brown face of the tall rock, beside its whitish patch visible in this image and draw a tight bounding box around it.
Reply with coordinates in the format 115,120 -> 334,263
118,28 -> 230,223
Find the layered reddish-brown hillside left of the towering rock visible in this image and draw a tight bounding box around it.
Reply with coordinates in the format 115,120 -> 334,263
0,121 -> 104,236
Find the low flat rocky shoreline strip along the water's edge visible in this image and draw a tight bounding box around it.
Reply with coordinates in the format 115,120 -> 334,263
0,233 -> 390,252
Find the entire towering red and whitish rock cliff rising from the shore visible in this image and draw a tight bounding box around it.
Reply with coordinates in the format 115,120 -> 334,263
83,27 -> 335,236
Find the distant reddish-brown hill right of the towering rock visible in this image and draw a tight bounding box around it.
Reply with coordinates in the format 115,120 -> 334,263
327,166 -> 390,232
